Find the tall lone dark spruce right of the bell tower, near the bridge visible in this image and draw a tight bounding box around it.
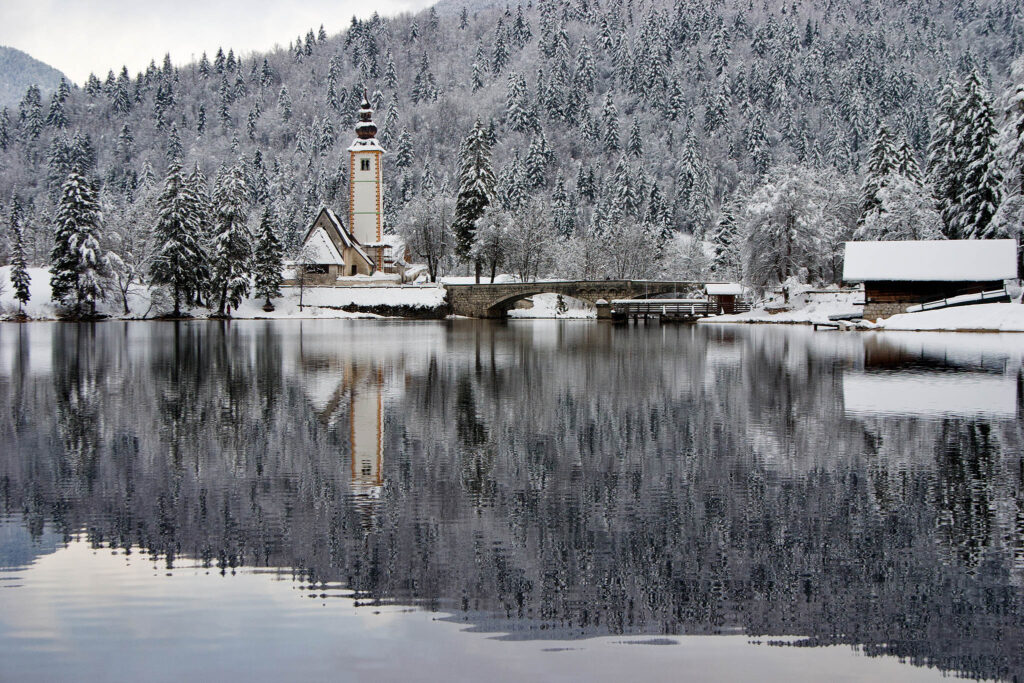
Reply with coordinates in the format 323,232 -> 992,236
453,119 -> 496,283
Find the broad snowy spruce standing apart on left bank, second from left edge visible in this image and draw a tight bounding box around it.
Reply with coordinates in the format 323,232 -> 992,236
50,171 -> 110,317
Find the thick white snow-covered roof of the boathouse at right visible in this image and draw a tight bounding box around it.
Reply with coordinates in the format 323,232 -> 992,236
843,240 -> 1017,283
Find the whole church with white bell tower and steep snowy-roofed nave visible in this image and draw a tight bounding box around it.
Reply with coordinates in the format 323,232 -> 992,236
296,93 -> 408,286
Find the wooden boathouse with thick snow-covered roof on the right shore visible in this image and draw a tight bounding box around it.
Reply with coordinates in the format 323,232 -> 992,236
843,240 -> 1017,321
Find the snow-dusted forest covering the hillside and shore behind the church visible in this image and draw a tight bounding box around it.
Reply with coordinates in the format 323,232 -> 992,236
0,0 -> 1024,308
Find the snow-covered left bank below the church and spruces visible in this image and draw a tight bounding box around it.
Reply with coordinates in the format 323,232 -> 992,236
0,266 -> 444,321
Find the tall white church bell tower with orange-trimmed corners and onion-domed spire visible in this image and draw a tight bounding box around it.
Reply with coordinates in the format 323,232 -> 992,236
348,91 -> 384,254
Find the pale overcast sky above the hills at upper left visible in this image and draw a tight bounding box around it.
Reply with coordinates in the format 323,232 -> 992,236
0,0 -> 433,85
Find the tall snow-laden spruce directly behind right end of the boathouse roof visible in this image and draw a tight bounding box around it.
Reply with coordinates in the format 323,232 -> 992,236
954,71 -> 1004,239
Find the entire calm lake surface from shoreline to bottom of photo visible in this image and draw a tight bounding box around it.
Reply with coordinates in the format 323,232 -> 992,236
0,321 -> 1024,681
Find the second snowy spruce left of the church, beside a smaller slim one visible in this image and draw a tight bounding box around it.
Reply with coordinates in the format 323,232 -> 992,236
211,163 -> 252,315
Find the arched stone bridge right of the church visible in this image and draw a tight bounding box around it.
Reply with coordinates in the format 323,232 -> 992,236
444,280 -> 703,317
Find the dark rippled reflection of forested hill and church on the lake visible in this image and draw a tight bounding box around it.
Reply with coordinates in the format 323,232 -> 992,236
0,322 -> 1024,677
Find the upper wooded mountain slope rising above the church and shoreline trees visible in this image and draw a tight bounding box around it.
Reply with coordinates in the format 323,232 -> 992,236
0,0 -> 1024,282
